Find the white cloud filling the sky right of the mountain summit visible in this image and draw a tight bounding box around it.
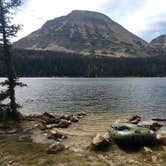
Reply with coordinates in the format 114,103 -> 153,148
101,0 -> 166,40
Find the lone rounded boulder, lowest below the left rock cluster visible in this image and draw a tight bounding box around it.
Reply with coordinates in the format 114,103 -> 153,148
47,142 -> 65,154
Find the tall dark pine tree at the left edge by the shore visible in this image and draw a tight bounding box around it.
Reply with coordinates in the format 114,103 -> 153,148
0,0 -> 22,120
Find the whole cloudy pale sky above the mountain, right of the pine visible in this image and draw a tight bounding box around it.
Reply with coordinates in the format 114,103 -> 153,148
14,0 -> 166,42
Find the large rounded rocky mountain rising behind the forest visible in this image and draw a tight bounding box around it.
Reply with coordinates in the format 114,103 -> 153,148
14,10 -> 163,57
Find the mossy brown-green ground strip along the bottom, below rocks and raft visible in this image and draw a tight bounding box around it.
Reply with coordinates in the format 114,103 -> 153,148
0,135 -> 166,166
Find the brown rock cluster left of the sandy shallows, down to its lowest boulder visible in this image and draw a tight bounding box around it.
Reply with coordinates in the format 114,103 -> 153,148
34,112 -> 86,154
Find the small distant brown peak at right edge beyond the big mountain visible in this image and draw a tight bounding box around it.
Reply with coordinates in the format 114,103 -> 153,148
151,35 -> 166,49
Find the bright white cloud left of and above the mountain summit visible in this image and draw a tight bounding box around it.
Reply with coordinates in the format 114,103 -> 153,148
14,0 -> 108,40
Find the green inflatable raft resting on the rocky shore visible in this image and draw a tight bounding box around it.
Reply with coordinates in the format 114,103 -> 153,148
109,123 -> 156,146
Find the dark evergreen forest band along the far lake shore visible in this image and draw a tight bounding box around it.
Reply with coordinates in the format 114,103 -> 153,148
0,50 -> 166,77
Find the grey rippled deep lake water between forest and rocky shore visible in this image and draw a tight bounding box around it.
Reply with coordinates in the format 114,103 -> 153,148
8,78 -> 166,120
